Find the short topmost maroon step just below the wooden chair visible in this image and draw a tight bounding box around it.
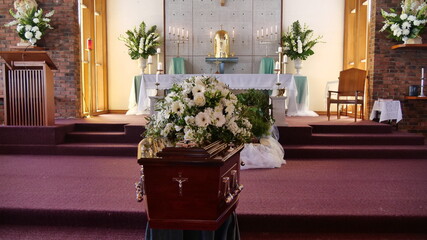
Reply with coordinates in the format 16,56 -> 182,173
310,123 -> 393,133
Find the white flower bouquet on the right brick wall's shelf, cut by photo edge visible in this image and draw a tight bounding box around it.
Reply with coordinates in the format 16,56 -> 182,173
380,0 -> 427,43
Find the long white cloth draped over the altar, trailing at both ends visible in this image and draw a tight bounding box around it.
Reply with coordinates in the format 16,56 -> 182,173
126,74 -> 317,116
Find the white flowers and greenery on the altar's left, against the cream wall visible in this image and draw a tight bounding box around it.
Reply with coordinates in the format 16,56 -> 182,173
119,22 -> 160,60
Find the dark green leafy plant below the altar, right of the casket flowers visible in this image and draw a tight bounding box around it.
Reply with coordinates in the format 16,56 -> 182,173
237,89 -> 274,138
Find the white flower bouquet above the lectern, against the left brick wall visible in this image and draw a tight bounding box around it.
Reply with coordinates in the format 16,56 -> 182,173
5,0 -> 55,45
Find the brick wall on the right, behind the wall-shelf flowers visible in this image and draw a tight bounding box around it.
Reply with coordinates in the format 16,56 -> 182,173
369,0 -> 427,134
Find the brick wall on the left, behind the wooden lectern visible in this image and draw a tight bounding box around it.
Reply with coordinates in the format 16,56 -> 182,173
0,0 -> 81,119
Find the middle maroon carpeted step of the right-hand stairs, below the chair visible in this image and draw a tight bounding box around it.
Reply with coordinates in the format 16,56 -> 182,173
310,132 -> 424,145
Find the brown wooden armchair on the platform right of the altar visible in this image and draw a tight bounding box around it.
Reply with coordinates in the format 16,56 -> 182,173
327,68 -> 367,121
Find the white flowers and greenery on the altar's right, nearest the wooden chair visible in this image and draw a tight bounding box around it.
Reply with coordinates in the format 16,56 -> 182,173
282,21 -> 322,60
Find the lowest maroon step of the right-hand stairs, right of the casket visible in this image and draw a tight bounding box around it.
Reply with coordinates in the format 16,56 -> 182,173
283,145 -> 427,160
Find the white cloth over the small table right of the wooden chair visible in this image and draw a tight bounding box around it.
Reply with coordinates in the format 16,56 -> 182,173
369,100 -> 402,123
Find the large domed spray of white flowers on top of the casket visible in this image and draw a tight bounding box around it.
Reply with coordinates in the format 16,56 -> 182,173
145,76 -> 253,146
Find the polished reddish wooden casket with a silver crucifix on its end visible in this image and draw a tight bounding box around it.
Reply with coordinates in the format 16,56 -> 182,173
138,142 -> 243,230
